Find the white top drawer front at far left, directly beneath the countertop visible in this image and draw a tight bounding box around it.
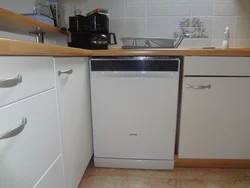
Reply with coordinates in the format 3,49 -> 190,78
0,57 -> 55,107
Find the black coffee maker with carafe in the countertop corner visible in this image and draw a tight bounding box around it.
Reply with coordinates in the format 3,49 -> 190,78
68,12 -> 117,50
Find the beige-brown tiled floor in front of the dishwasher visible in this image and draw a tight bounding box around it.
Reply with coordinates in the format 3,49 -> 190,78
79,162 -> 250,188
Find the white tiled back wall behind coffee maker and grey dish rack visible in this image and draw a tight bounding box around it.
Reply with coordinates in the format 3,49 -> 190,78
82,0 -> 250,47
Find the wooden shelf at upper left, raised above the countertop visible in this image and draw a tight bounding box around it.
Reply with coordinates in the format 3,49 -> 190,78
0,8 -> 67,37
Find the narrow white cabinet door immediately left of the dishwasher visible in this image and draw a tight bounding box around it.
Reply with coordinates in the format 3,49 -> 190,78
55,58 -> 93,188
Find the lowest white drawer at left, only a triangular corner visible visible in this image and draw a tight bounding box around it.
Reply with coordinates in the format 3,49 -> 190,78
34,155 -> 65,188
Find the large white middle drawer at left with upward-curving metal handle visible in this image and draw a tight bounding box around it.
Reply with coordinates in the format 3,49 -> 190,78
0,89 -> 61,188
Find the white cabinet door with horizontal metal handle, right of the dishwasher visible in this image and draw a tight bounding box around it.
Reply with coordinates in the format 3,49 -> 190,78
179,77 -> 250,159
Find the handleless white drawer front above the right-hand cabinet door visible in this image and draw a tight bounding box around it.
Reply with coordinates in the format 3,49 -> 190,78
184,57 -> 250,76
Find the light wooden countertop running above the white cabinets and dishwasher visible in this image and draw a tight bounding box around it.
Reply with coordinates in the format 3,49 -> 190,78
0,38 -> 250,57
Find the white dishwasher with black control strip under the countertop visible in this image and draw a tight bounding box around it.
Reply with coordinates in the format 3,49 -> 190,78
90,57 -> 180,170
